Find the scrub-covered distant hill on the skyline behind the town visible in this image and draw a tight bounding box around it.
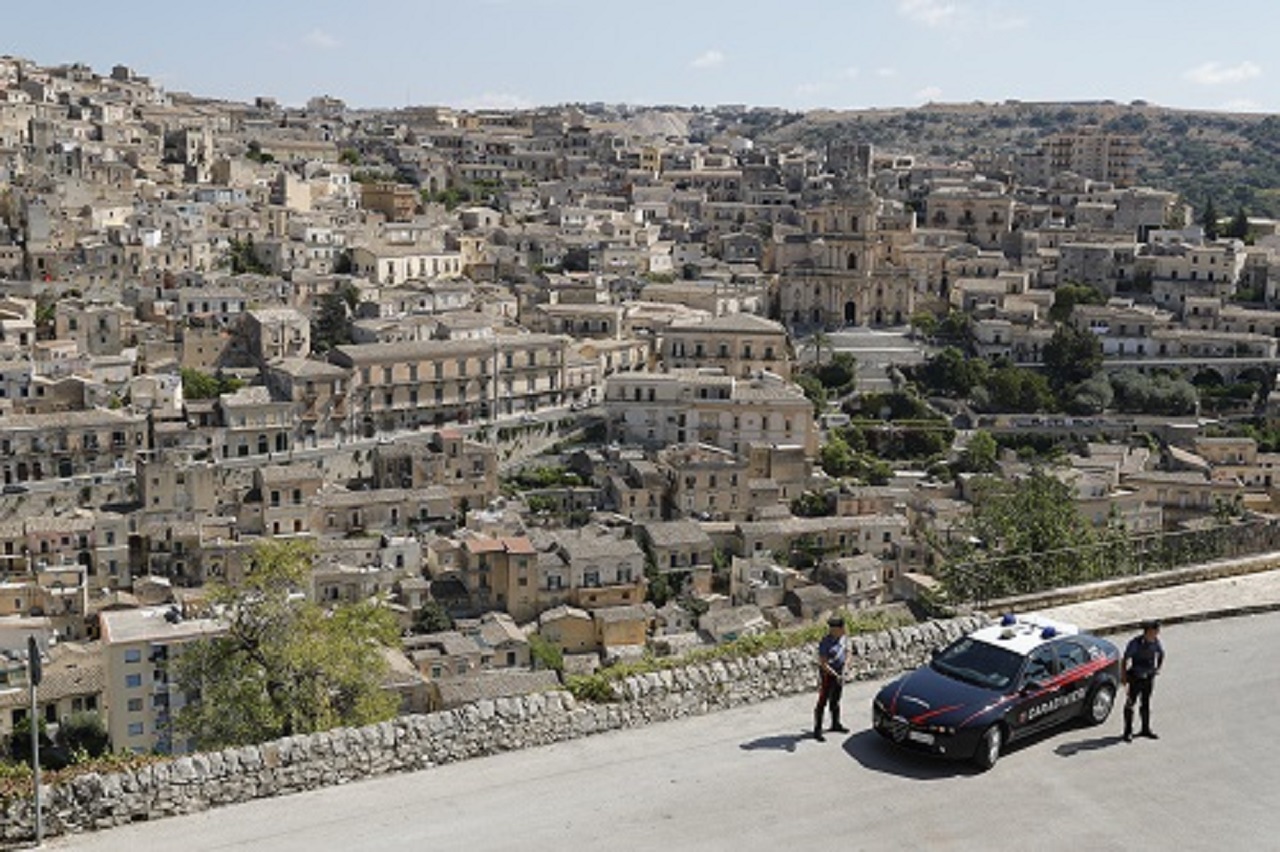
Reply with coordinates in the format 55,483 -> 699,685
762,101 -> 1280,216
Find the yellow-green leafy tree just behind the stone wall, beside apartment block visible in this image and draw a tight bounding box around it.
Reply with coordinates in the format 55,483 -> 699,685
173,540 -> 399,750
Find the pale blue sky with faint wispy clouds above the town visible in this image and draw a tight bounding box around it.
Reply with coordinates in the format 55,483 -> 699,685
0,0 -> 1280,113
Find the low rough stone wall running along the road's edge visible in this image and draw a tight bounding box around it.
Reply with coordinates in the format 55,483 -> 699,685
0,617 -> 986,844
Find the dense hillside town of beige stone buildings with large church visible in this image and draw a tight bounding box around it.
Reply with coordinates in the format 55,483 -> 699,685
0,56 -> 1280,752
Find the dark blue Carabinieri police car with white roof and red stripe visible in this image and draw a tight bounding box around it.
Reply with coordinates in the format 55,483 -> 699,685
872,615 -> 1120,769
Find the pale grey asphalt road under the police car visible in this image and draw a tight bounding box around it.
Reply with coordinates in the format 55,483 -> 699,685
47,614 -> 1280,852
